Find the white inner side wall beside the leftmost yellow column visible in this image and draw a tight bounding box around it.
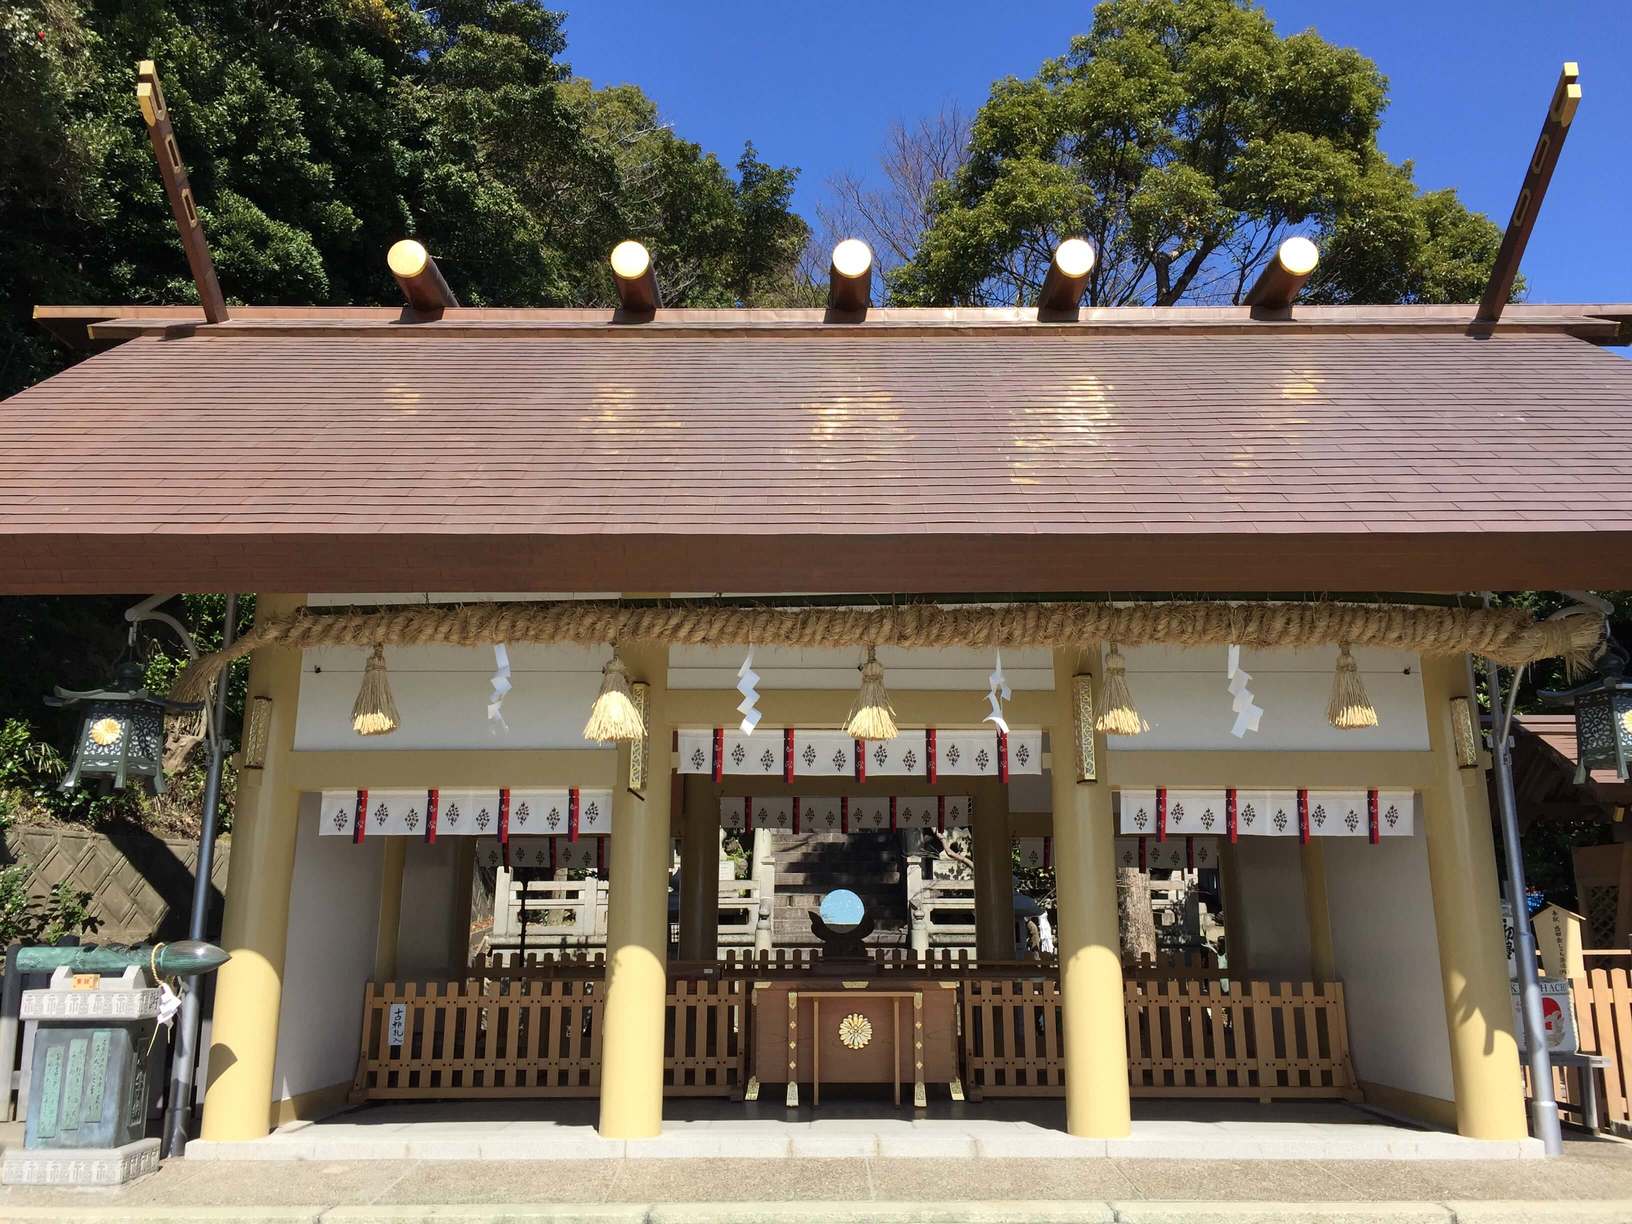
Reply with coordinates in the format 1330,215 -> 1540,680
273,795 -> 382,1100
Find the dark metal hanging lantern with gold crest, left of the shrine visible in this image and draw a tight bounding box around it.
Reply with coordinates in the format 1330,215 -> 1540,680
46,659 -> 204,795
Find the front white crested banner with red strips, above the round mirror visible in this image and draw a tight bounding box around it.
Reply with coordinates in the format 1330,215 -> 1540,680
677,726 -> 1043,782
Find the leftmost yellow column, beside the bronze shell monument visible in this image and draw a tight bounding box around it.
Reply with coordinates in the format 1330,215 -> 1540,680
201,596 -> 305,1139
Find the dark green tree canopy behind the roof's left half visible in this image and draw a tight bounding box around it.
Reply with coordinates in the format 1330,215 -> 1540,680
0,0 -> 808,395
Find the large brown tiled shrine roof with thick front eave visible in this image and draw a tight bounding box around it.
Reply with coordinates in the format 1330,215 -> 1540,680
0,326 -> 1632,591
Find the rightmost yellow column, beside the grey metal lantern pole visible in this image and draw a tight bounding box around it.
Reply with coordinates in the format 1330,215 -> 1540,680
1423,658 -> 1528,1139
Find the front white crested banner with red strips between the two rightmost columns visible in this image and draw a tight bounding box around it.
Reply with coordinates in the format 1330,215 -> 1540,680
1116,787 -> 1417,840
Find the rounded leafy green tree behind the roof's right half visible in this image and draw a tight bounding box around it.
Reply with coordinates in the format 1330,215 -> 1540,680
891,0 -> 1500,305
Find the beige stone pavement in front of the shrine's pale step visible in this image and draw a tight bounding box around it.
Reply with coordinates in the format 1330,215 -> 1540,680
0,1115 -> 1632,1224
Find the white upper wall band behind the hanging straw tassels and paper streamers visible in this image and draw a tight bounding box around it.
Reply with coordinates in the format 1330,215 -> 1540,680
295,592 -> 1428,752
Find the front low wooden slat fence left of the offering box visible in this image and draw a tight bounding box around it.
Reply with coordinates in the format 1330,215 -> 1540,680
351,976 -> 747,1102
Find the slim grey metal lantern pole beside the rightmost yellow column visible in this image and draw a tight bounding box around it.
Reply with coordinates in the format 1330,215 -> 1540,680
1485,658 -> 1563,1155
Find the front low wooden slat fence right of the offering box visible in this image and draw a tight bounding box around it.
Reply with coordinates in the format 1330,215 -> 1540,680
963,978 -> 1359,1102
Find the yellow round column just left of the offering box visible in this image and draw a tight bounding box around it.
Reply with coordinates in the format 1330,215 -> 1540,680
601,646 -> 672,1139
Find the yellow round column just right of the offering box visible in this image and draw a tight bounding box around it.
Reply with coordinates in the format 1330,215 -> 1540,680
1049,648 -> 1131,1139
